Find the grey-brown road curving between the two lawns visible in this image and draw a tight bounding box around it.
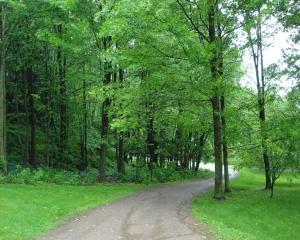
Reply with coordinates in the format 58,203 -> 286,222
39,165 -> 237,240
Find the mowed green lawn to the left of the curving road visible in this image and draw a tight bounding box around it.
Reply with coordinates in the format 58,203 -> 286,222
0,184 -> 145,240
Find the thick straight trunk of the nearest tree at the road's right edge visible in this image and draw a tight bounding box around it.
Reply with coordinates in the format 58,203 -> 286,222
208,0 -> 224,200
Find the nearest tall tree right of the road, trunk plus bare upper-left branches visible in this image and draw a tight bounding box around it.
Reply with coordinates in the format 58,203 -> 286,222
176,0 -> 224,199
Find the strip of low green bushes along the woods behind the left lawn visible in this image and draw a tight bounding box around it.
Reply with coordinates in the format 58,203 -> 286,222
0,164 -> 211,185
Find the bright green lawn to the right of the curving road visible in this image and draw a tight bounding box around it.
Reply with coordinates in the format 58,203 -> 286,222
192,170 -> 300,240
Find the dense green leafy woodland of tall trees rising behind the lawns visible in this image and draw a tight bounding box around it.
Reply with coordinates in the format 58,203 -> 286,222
0,0 -> 300,199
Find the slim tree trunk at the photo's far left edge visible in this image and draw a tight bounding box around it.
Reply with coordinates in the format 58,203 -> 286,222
0,3 -> 7,175
